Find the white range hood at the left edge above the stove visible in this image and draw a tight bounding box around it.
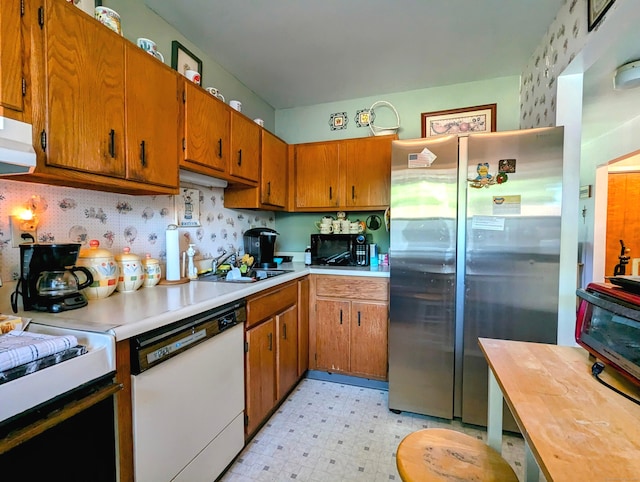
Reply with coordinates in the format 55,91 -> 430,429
0,117 -> 36,176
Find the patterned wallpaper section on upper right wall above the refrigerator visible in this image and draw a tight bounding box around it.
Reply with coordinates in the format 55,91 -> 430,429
520,0 -> 592,129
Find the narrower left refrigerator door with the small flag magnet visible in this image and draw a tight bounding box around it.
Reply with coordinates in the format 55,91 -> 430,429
389,136 -> 458,418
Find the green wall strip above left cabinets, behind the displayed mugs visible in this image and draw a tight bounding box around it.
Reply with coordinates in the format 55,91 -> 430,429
102,0 -> 275,132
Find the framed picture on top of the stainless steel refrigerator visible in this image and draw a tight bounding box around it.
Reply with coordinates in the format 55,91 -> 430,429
422,104 -> 496,137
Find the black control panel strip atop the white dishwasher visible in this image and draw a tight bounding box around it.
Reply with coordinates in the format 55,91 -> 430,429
131,300 -> 247,375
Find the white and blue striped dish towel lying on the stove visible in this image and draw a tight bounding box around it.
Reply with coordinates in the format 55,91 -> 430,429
0,330 -> 78,371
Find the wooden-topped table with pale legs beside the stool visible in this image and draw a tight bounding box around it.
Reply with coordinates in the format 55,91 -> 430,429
479,338 -> 640,482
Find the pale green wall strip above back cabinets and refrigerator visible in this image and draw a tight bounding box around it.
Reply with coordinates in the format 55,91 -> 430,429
276,76 -> 520,144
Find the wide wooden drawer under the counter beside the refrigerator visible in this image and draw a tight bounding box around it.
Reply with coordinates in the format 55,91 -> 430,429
316,275 -> 389,301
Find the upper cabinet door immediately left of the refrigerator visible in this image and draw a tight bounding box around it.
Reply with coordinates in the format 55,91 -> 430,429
341,137 -> 392,207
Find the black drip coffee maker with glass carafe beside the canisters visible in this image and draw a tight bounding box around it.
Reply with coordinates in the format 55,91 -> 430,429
11,243 -> 93,313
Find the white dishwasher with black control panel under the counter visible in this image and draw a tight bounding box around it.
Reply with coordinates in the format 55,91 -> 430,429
131,301 -> 246,482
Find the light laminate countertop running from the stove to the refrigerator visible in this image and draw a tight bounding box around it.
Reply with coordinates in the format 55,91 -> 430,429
0,262 -> 389,341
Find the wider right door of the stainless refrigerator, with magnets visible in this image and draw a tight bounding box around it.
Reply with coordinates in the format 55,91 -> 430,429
462,127 -> 563,430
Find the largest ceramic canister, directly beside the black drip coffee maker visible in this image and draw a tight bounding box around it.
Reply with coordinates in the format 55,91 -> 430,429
76,239 -> 119,300
